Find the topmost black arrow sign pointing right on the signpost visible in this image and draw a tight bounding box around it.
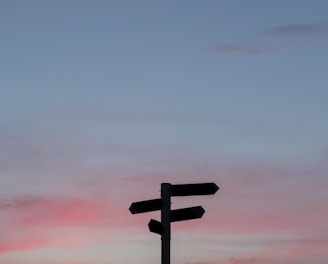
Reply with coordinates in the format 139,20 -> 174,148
171,182 -> 219,196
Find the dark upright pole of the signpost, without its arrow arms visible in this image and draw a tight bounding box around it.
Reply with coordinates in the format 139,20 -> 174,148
161,183 -> 171,264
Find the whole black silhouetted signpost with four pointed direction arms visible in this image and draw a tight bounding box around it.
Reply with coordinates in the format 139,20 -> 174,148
129,182 -> 219,264
